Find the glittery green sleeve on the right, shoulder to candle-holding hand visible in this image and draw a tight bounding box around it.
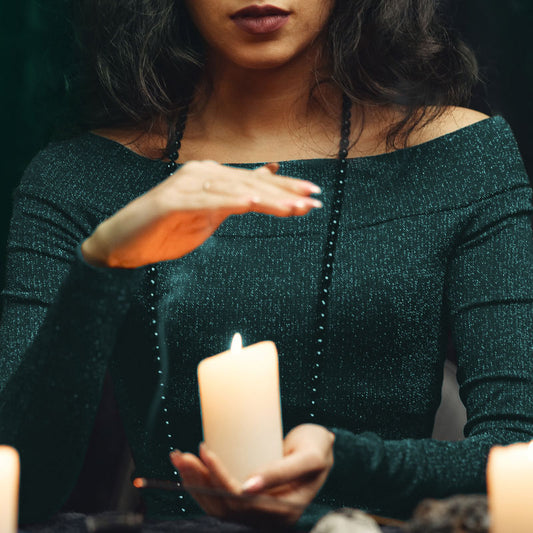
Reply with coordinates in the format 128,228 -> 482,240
320,158 -> 533,516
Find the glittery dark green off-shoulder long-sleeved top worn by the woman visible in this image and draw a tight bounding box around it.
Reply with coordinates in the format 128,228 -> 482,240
0,117 -> 533,527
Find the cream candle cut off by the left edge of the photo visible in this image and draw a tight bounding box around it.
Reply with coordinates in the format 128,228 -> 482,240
0,446 -> 20,533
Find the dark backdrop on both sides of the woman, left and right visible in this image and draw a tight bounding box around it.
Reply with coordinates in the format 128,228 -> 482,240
0,0 -> 533,286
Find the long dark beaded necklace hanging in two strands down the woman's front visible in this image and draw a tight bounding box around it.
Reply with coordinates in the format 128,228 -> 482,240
148,95 -> 351,514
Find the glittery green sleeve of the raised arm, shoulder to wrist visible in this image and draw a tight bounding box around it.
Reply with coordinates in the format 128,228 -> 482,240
0,152 -> 142,523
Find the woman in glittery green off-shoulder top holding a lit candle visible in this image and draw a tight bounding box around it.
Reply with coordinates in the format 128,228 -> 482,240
0,0 -> 533,527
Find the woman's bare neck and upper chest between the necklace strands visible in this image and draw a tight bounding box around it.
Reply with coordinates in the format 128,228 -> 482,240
182,46 -> 341,162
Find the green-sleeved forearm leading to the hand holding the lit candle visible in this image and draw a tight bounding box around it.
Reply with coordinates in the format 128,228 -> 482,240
323,429 -> 533,518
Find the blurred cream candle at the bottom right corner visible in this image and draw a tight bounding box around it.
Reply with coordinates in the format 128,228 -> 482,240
487,442 -> 533,533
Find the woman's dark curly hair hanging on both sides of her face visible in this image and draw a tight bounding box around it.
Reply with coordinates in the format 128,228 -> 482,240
72,0 -> 477,148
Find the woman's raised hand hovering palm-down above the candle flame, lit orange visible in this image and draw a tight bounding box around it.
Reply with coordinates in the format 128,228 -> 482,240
81,161 -> 322,268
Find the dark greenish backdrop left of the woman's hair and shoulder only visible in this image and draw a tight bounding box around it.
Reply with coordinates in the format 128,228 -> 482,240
0,0 -> 74,287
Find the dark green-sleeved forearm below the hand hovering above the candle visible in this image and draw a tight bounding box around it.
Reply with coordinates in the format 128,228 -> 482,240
0,251 -> 141,521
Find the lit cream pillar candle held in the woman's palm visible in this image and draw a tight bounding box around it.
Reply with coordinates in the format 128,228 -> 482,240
198,333 -> 283,482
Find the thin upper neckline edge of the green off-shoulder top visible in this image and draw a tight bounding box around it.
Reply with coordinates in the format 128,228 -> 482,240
86,115 -> 500,167
